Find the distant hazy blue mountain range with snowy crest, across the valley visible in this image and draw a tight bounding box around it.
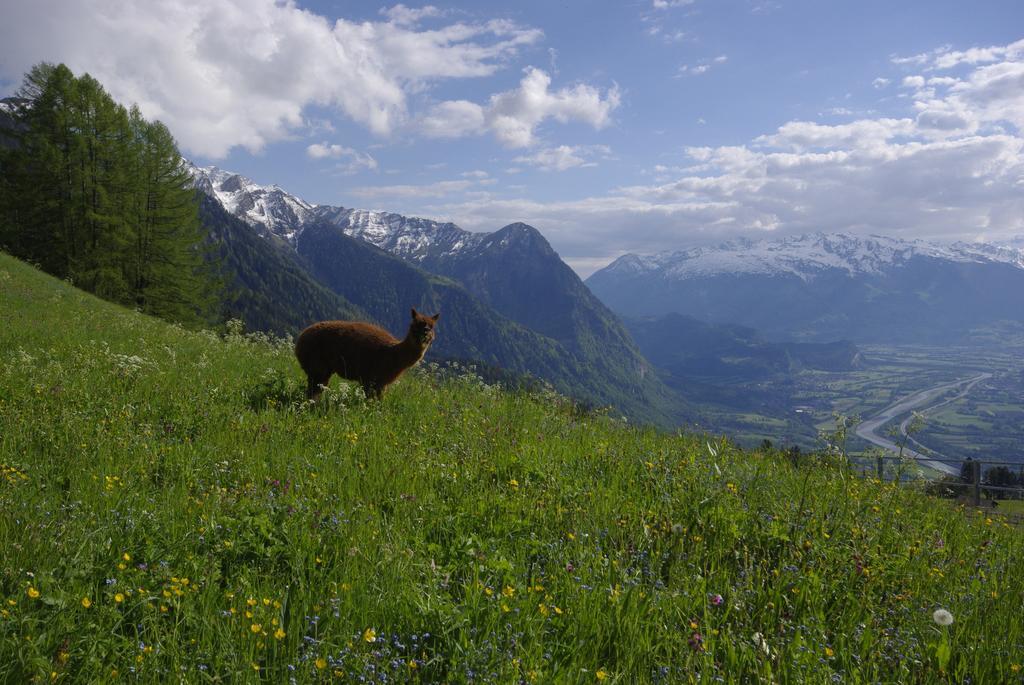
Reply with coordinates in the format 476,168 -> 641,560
587,233 -> 1024,344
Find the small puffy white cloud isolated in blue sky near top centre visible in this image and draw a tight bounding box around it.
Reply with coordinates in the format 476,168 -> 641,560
419,67 -> 621,147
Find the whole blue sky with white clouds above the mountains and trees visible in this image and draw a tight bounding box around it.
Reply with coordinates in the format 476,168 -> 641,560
0,0 -> 1024,275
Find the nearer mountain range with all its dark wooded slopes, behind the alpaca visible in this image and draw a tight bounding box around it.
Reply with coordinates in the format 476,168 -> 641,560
189,166 -> 691,426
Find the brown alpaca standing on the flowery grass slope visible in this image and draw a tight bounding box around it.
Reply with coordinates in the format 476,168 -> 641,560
295,309 -> 440,401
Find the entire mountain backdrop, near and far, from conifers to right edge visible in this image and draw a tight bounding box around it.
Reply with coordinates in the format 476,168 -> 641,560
190,160 -> 1024,428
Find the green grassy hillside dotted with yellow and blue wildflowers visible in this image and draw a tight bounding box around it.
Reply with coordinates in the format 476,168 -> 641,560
0,256 -> 1024,683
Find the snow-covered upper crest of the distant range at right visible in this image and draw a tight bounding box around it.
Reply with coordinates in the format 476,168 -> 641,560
599,233 -> 1024,281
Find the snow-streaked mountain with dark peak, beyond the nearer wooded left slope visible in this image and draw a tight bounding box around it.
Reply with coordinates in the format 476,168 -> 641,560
188,165 -> 683,420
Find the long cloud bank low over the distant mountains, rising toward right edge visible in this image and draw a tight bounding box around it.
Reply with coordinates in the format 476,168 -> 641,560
429,39 -> 1024,274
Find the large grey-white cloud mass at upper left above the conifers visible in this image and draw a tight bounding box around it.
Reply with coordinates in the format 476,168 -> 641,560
0,0 -> 543,158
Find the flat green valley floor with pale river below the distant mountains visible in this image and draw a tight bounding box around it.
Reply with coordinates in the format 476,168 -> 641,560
696,345 -> 1024,462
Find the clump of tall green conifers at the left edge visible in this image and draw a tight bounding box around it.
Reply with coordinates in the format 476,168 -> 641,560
0,63 -> 214,323
